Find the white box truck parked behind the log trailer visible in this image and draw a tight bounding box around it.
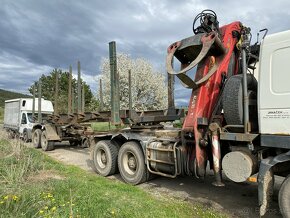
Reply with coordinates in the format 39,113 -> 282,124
4,98 -> 53,141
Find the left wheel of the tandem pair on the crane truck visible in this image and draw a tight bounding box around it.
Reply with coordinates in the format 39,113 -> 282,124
91,140 -> 118,176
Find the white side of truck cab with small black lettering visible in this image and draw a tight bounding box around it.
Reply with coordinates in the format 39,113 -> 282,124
258,31 -> 290,135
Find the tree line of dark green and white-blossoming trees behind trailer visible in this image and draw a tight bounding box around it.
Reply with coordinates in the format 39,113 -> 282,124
28,54 -> 167,113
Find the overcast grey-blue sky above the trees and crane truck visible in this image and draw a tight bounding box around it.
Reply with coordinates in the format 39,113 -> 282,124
0,0 -> 290,105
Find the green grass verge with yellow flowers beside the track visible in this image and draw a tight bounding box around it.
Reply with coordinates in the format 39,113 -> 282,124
0,136 -> 227,218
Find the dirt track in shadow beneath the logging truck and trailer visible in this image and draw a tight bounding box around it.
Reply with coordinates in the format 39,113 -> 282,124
42,143 -> 282,218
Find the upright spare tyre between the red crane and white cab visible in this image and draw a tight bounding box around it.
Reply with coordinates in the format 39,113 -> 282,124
222,74 -> 257,125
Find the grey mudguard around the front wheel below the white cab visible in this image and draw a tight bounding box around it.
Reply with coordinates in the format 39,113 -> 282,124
258,151 -> 290,216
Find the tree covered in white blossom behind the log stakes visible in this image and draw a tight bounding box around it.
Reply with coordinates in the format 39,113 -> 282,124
101,54 -> 167,111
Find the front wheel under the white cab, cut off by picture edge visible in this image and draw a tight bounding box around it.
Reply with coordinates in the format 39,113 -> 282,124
279,175 -> 290,218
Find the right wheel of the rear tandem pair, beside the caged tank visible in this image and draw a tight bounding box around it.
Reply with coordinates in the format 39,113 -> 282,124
118,141 -> 148,185
